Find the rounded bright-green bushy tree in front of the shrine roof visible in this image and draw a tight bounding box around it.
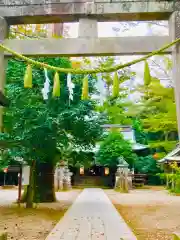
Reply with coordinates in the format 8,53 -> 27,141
96,132 -> 136,167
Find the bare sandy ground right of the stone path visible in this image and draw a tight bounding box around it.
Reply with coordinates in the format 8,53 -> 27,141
106,187 -> 180,240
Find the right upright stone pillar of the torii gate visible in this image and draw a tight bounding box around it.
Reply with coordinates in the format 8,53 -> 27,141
169,11 -> 180,141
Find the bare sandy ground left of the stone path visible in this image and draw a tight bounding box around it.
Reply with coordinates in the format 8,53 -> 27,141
0,190 -> 80,240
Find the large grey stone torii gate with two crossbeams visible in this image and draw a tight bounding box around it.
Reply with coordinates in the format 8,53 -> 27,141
0,0 -> 180,139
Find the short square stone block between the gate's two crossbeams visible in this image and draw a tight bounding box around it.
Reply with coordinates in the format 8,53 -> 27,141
78,18 -> 98,38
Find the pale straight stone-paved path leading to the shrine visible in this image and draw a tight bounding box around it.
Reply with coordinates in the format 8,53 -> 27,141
46,189 -> 136,240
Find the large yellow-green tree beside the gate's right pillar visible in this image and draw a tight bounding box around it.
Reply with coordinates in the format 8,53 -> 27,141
129,78 -> 177,152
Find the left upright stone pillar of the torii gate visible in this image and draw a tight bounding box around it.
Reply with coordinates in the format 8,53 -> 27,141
0,17 -> 9,132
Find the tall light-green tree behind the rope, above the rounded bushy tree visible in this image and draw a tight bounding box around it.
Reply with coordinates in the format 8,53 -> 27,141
97,57 -> 135,125
